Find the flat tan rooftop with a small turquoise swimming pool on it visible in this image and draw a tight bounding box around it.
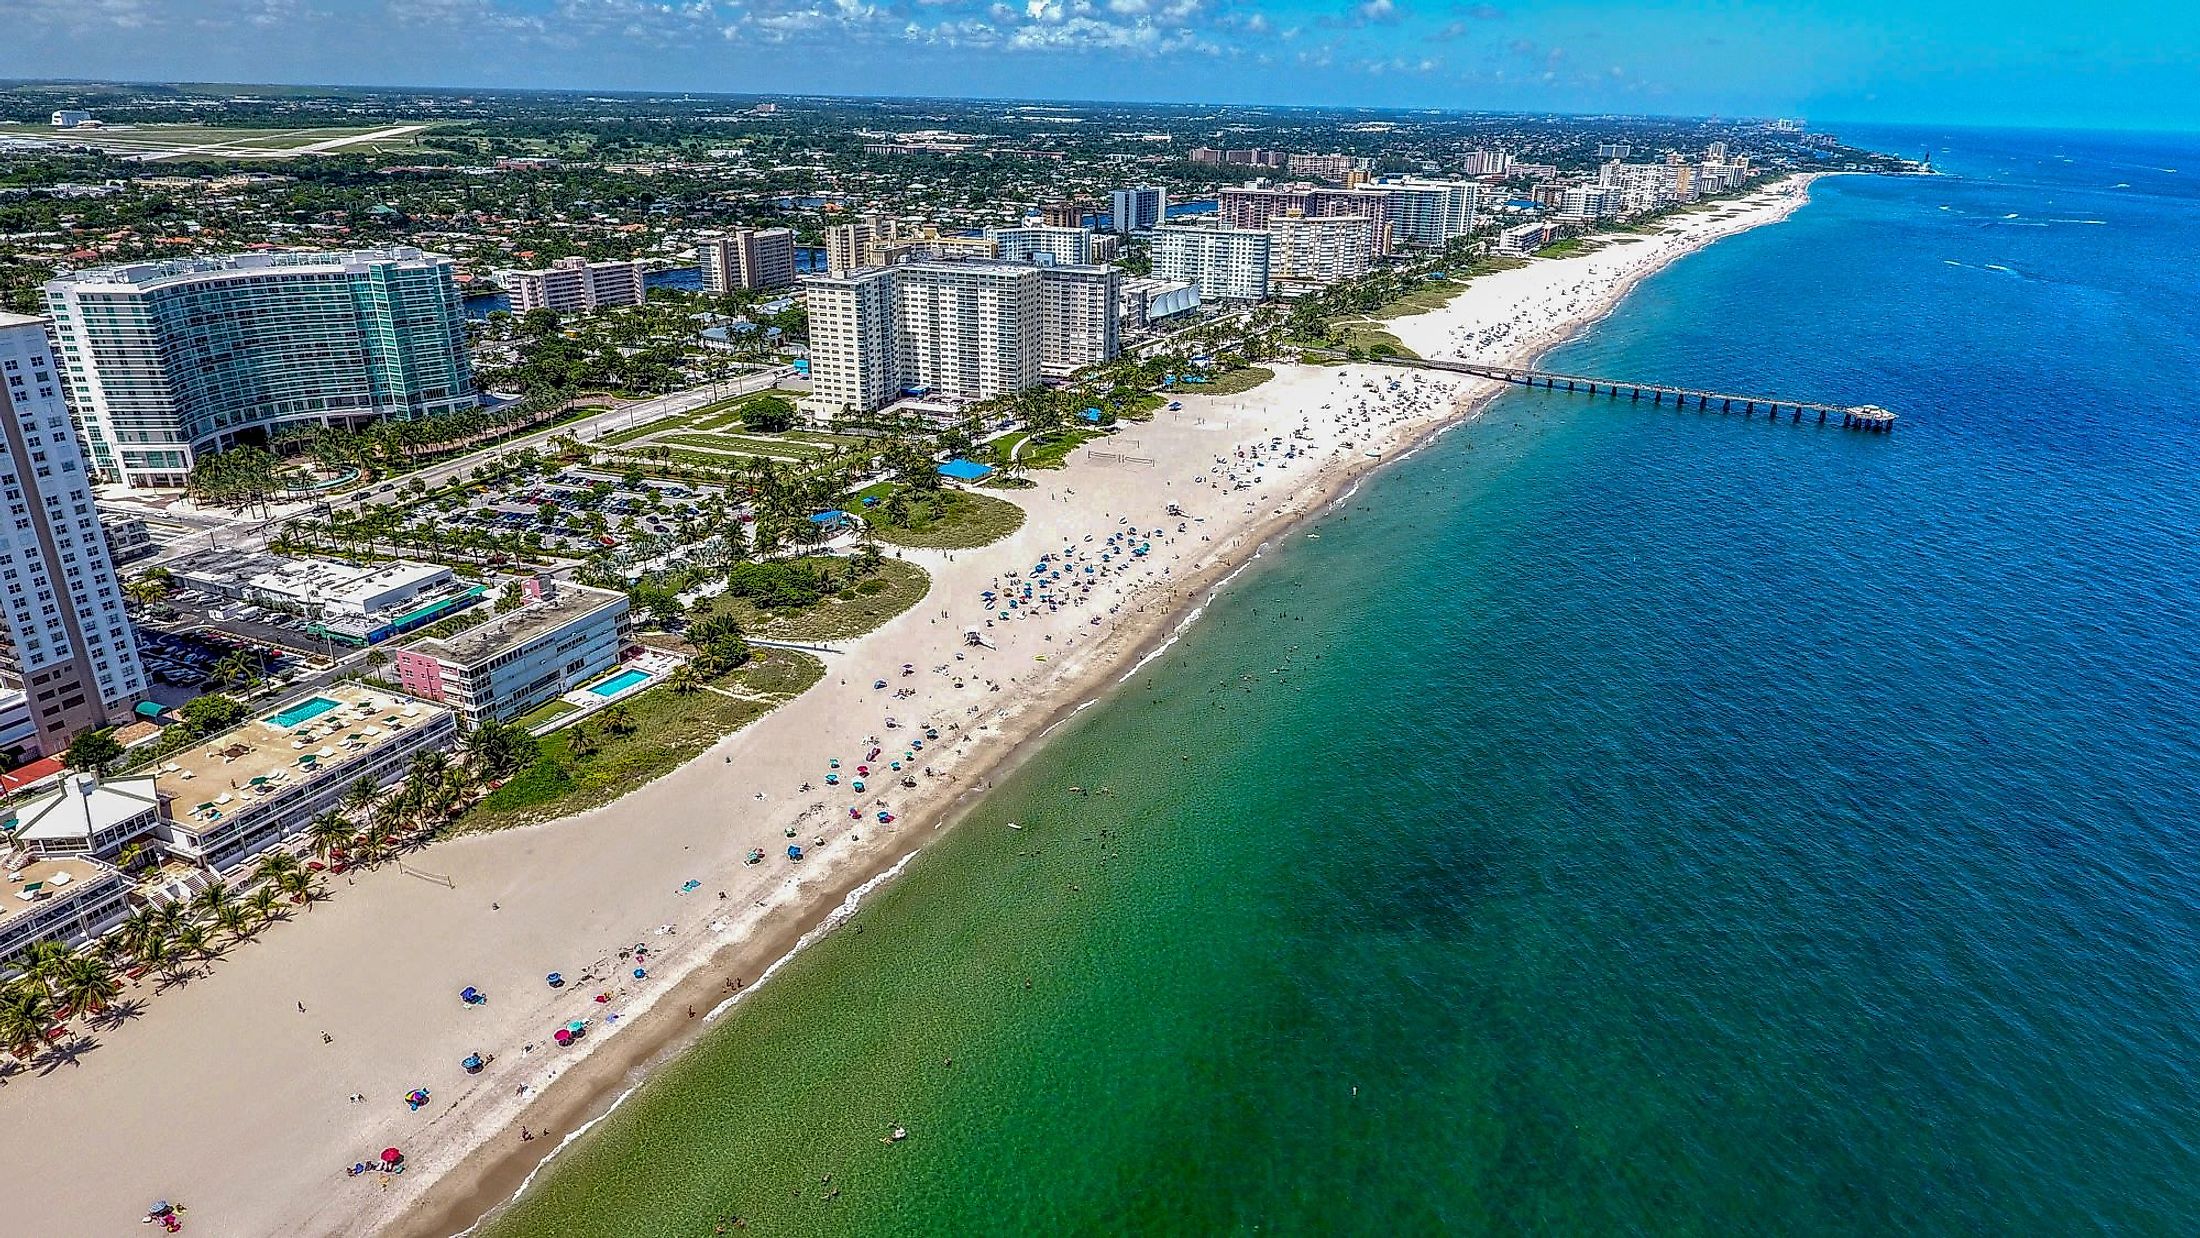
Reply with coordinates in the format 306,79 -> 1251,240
152,684 -> 449,822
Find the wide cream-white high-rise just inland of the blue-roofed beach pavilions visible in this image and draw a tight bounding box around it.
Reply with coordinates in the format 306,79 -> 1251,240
803,259 -> 1122,418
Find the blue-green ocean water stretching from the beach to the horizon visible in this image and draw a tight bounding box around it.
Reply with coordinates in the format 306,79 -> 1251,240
481,132 -> 2200,1236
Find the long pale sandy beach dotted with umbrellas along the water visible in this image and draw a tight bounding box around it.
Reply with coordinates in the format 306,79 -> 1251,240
0,178 -> 1806,1236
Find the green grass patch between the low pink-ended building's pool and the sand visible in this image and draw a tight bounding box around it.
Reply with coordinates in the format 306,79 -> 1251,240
458,649 -> 825,833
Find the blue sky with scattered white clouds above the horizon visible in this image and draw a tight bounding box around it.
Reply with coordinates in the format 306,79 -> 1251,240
0,0 -> 2200,130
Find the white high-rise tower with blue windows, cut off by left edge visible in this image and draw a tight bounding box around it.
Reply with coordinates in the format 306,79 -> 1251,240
0,312 -> 145,754
